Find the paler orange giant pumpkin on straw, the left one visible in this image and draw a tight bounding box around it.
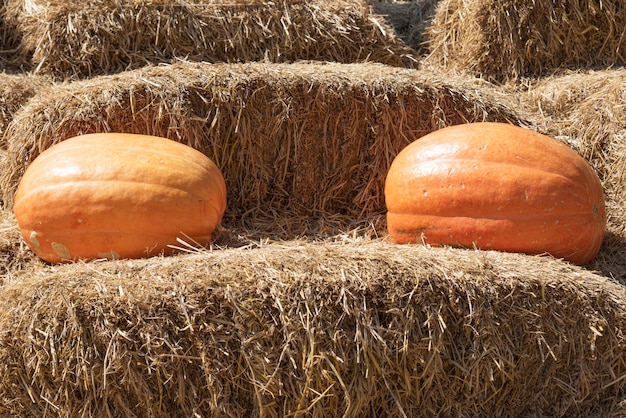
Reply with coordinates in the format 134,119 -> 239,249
14,133 -> 226,263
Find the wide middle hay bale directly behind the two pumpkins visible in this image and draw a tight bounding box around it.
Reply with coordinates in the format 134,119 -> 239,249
2,63 -> 517,238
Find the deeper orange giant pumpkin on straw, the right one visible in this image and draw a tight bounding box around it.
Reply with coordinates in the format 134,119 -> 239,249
384,122 -> 606,264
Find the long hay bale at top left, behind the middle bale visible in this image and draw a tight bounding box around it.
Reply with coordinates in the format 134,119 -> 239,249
6,0 -> 415,78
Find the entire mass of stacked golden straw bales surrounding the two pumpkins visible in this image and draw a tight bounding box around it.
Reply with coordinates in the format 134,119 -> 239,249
0,0 -> 626,418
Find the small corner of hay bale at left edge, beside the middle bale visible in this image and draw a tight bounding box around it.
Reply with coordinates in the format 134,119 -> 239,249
0,73 -> 52,144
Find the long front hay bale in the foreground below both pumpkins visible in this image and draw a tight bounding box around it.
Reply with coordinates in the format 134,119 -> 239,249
0,241 -> 626,417
